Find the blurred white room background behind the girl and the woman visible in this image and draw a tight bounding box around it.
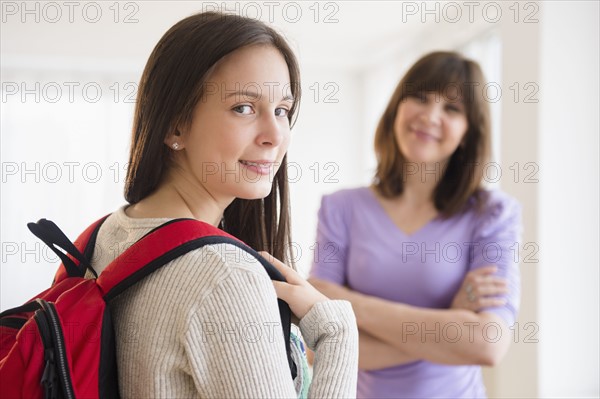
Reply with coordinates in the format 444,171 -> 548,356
0,1 -> 600,398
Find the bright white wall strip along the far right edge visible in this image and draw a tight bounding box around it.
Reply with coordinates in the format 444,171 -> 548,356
538,2 -> 600,397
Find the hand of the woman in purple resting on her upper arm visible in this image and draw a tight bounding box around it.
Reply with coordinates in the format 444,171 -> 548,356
450,265 -> 508,312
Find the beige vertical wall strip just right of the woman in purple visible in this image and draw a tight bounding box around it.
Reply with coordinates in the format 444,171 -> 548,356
488,3 -> 543,398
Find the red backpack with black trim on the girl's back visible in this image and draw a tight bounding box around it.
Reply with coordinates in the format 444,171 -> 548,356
0,217 -> 296,399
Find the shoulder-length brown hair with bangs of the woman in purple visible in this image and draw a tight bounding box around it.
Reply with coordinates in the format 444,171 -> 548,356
374,51 -> 490,217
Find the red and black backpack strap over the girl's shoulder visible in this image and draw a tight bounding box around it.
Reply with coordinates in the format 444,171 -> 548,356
97,219 -> 297,378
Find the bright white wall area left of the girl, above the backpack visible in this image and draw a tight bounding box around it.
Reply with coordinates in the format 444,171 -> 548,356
0,67 -> 135,309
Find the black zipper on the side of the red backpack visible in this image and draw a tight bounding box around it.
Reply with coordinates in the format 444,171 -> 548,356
35,299 -> 75,399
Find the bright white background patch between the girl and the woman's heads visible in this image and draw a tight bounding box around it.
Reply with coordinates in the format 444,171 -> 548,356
288,68 -> 366,274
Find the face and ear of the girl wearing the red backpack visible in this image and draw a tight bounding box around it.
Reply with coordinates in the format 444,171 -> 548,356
165,46 -> 293,202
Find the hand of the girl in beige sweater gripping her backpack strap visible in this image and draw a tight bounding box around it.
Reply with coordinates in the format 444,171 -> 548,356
259,251 -> 329,319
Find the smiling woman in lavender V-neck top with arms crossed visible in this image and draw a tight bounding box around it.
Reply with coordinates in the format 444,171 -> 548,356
309,52 -> 521,398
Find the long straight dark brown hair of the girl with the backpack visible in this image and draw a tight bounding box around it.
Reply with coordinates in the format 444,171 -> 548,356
125,12 -> 300,264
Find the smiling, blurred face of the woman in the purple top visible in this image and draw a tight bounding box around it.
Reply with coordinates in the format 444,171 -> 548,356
394,92 -> 469,166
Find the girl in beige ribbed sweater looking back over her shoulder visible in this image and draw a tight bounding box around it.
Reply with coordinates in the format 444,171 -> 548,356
92,13 -> 358,398
